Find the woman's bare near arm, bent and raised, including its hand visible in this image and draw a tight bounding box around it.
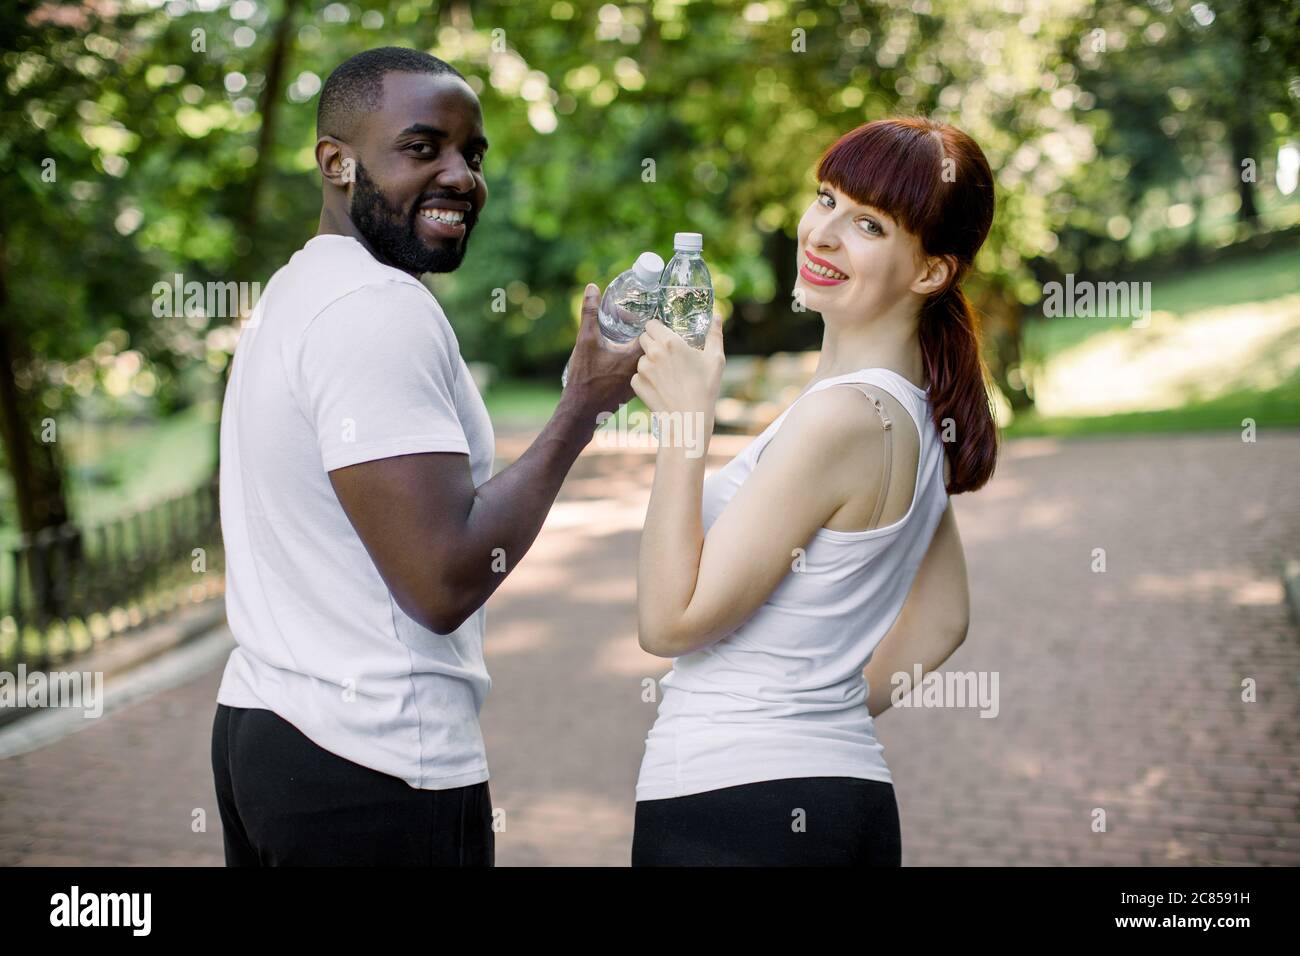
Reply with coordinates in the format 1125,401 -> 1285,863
632,323 -> 884,657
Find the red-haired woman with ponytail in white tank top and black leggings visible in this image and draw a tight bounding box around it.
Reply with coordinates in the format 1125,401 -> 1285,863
632,118 -> 997,865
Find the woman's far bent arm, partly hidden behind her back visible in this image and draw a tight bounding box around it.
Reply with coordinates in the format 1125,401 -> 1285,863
863,502 -> 970,717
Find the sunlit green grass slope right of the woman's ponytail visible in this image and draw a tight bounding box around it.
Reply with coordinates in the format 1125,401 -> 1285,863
1005,245 -> 1300,436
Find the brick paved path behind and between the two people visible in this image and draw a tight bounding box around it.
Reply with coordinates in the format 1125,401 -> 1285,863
0,432 -> 1300,866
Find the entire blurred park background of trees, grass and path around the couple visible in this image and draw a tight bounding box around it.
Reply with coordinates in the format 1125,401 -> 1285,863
0,0 -> 1300,865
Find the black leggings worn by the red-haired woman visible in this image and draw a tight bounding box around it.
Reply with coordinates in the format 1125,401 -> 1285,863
632,777 -> 902,866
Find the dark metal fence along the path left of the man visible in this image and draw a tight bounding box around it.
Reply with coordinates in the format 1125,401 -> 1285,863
0,480 -> 225,669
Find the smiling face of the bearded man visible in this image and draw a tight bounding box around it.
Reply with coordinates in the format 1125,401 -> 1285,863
348,73 -> 488,274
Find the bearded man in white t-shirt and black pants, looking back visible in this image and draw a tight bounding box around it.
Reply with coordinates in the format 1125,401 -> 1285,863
212,47 -> 641,865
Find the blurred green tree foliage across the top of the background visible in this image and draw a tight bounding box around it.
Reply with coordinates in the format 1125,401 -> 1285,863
0,0 -> 1300,528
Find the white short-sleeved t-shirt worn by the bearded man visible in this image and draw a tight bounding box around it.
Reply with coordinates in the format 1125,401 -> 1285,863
217,235 -> 494,790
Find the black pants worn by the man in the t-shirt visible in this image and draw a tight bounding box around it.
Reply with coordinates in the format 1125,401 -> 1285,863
212,704 -> 495,866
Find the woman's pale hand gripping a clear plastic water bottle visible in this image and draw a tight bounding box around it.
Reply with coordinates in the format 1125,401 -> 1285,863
632,316 -> 727,423
